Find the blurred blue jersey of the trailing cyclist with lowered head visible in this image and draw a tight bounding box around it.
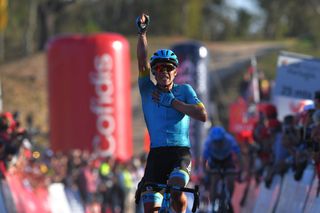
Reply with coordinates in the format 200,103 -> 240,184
203,128 -> 240,160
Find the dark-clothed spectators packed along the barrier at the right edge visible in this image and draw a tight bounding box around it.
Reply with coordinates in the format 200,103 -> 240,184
252,98 -> 320,187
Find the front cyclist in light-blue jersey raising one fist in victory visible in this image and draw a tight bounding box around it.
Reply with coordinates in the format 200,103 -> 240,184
136,14 -> 207,212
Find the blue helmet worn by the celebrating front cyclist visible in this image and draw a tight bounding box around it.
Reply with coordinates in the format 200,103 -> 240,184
150,49 -> 179,67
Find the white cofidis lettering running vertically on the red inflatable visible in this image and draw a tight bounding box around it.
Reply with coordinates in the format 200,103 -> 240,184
89,54 -> 116,155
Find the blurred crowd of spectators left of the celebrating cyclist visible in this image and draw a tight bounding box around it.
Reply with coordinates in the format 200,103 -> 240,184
0,112 -> 146,213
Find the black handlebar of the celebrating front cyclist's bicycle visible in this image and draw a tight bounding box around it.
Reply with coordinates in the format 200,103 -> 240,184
144,182 -> 199,212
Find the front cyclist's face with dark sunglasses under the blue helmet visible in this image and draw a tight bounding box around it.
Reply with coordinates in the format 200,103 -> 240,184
152,63 -> 177,86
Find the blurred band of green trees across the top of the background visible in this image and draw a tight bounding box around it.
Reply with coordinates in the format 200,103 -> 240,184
4,0 -> 320,59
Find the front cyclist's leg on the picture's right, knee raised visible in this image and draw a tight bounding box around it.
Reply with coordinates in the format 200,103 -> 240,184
168,148 -> 191,212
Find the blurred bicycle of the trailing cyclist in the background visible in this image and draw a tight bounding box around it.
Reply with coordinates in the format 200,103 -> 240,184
207,167 -> 239,213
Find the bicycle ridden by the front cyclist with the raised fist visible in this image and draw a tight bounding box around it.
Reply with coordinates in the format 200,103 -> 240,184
137,182 -> 199,213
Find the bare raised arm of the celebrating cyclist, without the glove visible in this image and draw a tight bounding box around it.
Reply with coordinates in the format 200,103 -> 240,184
137,14 -> 150,77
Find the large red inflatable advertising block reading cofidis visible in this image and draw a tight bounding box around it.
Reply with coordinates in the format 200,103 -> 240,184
48,33 -> 133,160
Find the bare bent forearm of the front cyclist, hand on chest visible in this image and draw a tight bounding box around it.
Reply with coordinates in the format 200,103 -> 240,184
172,99 -> 208,122
